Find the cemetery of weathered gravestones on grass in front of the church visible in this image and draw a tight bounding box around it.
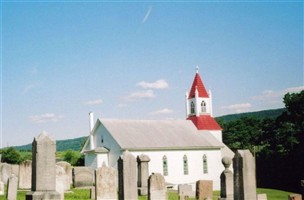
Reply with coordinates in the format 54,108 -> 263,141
0,132 -> 301,200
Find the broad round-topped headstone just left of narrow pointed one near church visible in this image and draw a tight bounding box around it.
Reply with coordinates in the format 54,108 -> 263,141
95,165 -> 117,200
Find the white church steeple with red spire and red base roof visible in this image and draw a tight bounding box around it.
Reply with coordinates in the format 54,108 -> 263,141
186,66 -> 222,130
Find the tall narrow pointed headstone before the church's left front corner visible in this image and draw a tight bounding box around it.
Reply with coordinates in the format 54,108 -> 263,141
118,151 -> 138,200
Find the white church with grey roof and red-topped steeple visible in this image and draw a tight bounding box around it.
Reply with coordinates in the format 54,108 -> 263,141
81,68 -> 234,190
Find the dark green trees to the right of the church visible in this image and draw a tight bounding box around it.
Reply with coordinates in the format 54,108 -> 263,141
218,90 -> 304,192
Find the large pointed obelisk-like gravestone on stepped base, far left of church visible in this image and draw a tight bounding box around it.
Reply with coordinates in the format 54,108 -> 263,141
26,132 -> 60,200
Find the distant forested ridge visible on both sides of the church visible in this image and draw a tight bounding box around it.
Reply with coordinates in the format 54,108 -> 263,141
16,108 -> 285,151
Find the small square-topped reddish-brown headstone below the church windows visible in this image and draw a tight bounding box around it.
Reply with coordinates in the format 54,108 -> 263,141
196,180 -> 213,200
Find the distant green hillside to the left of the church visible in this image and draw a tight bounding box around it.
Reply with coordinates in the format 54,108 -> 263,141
16,137 -> 87,151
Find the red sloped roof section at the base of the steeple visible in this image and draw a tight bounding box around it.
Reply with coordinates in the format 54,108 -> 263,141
188,115 -> 222,130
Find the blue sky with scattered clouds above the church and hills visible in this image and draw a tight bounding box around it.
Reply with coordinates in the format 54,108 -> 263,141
0,0 -> 304,147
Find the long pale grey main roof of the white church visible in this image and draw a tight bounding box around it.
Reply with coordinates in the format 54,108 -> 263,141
99,119 -> 224,150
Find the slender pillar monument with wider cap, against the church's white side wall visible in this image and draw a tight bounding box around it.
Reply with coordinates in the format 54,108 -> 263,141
137,154 -> 150,195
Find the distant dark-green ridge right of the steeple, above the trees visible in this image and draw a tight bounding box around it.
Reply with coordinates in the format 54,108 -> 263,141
215,108 -> 286,122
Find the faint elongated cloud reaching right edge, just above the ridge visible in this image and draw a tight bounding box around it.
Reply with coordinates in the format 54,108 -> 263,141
252,86 -> 304,103
